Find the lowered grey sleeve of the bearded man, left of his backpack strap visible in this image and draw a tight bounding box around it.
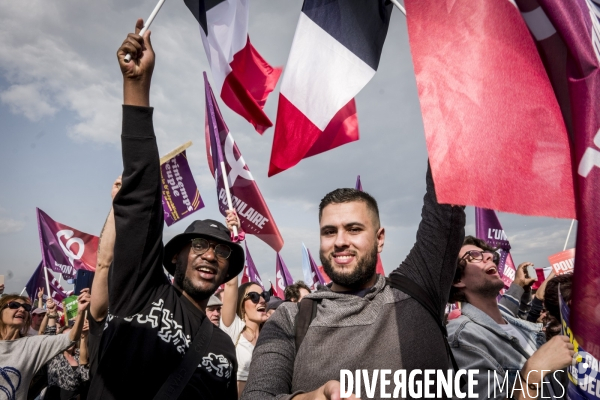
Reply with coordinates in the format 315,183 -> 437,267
241,303 -> 302,400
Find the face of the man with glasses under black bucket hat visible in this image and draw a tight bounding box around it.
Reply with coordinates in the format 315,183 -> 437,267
173,240 -> 229,301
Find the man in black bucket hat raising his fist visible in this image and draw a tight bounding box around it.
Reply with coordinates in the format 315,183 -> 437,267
88,19 -> 244,400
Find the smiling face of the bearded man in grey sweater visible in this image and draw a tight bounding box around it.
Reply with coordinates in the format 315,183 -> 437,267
319,201 -> 385,291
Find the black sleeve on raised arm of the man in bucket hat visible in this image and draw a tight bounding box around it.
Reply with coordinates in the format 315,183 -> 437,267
108,105 -> 167,317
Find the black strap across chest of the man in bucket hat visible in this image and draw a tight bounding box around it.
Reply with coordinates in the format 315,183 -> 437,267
154,317 -> 214,400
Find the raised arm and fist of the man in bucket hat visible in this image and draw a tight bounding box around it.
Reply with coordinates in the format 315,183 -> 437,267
109,19 -> 167,317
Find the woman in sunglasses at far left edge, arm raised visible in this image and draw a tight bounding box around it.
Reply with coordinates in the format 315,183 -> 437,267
0,293 -> 89,400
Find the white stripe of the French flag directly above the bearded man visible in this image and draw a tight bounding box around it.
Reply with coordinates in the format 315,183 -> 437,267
281,13 -> 375,130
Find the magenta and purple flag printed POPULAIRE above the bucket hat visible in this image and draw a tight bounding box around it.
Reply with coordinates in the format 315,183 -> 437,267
204,73 -> 283,251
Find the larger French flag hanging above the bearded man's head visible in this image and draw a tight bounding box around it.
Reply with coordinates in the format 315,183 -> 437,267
269,0 -> 392,176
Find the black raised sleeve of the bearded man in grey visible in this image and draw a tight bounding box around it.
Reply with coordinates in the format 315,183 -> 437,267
392,161 -> 465,318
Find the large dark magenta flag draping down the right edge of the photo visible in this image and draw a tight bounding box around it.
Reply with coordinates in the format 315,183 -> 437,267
517,0 -> 600,358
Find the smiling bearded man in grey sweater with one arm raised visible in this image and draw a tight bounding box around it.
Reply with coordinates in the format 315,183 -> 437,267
242,163 -> 465,400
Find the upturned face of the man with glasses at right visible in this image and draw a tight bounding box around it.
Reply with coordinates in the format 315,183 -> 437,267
454,244 -> 504,300
